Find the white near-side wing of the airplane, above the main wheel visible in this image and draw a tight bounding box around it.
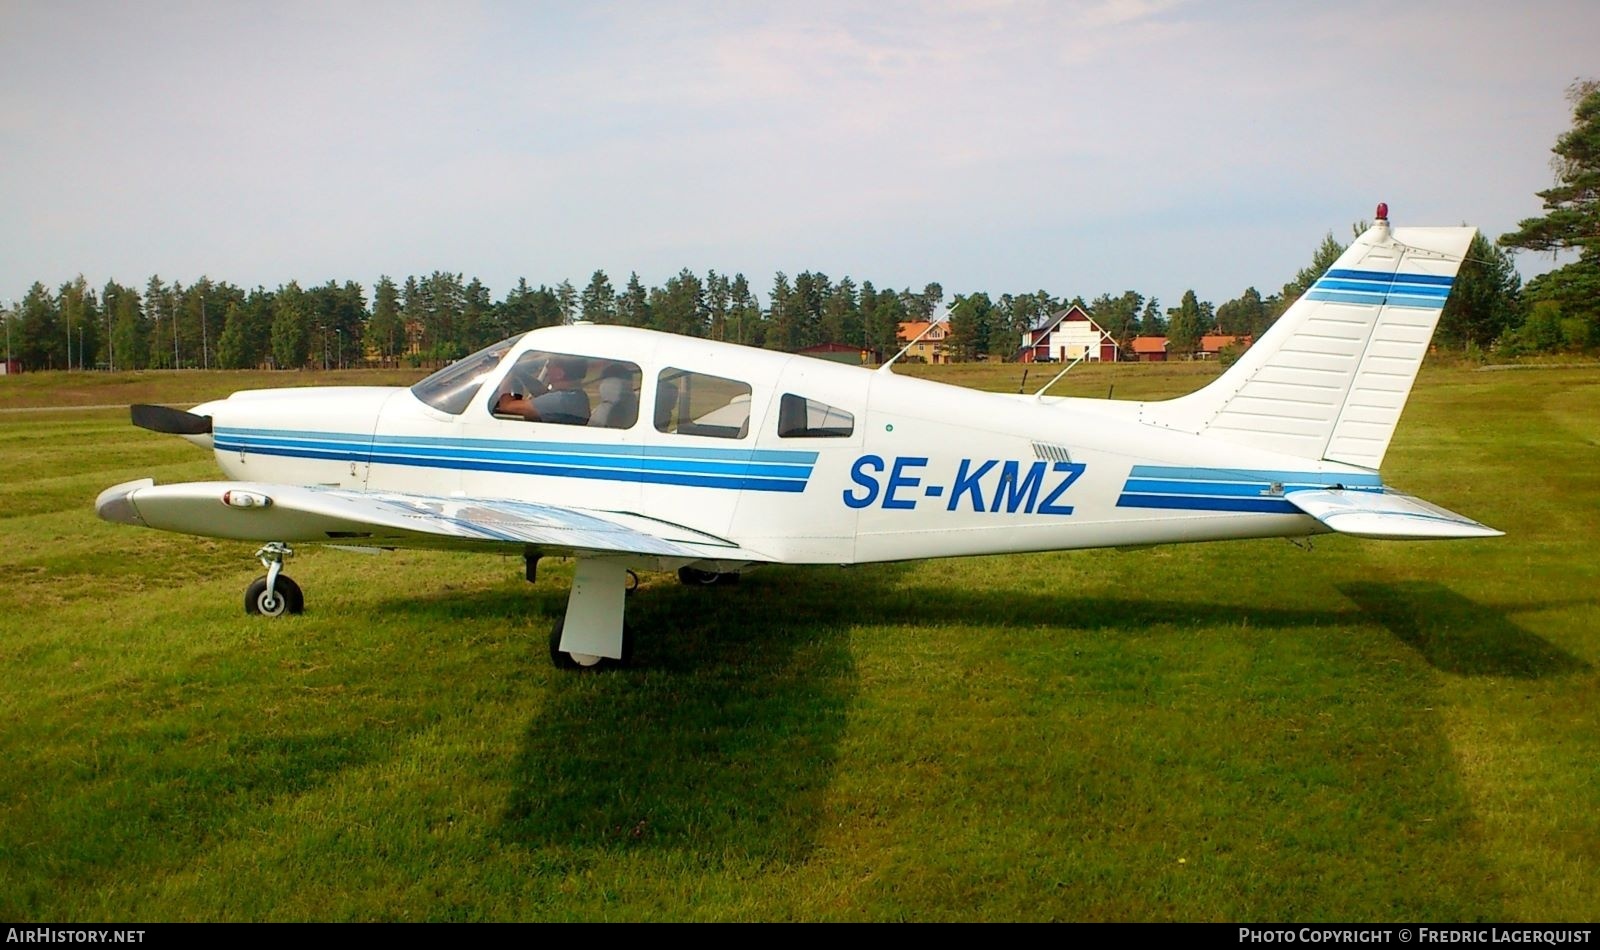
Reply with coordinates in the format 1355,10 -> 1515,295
94,478 -> 771,561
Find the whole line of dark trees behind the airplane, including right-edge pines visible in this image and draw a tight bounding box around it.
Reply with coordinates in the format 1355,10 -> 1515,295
5,80 -> 1600,369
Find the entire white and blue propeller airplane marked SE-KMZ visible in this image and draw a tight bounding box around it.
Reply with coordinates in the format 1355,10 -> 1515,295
96,205 -> 1499,669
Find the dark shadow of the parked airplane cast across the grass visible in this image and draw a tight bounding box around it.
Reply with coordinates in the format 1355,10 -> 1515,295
476,565 -> 1587,864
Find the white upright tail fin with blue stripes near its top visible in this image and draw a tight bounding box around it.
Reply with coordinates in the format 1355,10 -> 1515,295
1141,206 -> 1477,469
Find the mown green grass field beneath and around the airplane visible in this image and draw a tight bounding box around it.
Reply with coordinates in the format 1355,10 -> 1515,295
0,365 -> 1600,921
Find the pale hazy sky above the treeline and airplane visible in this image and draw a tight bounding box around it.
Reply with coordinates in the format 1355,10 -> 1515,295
0,0 -> 1600,305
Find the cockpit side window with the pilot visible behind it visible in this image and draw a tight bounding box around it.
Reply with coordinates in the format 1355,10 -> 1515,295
490,350 -> 645,429
